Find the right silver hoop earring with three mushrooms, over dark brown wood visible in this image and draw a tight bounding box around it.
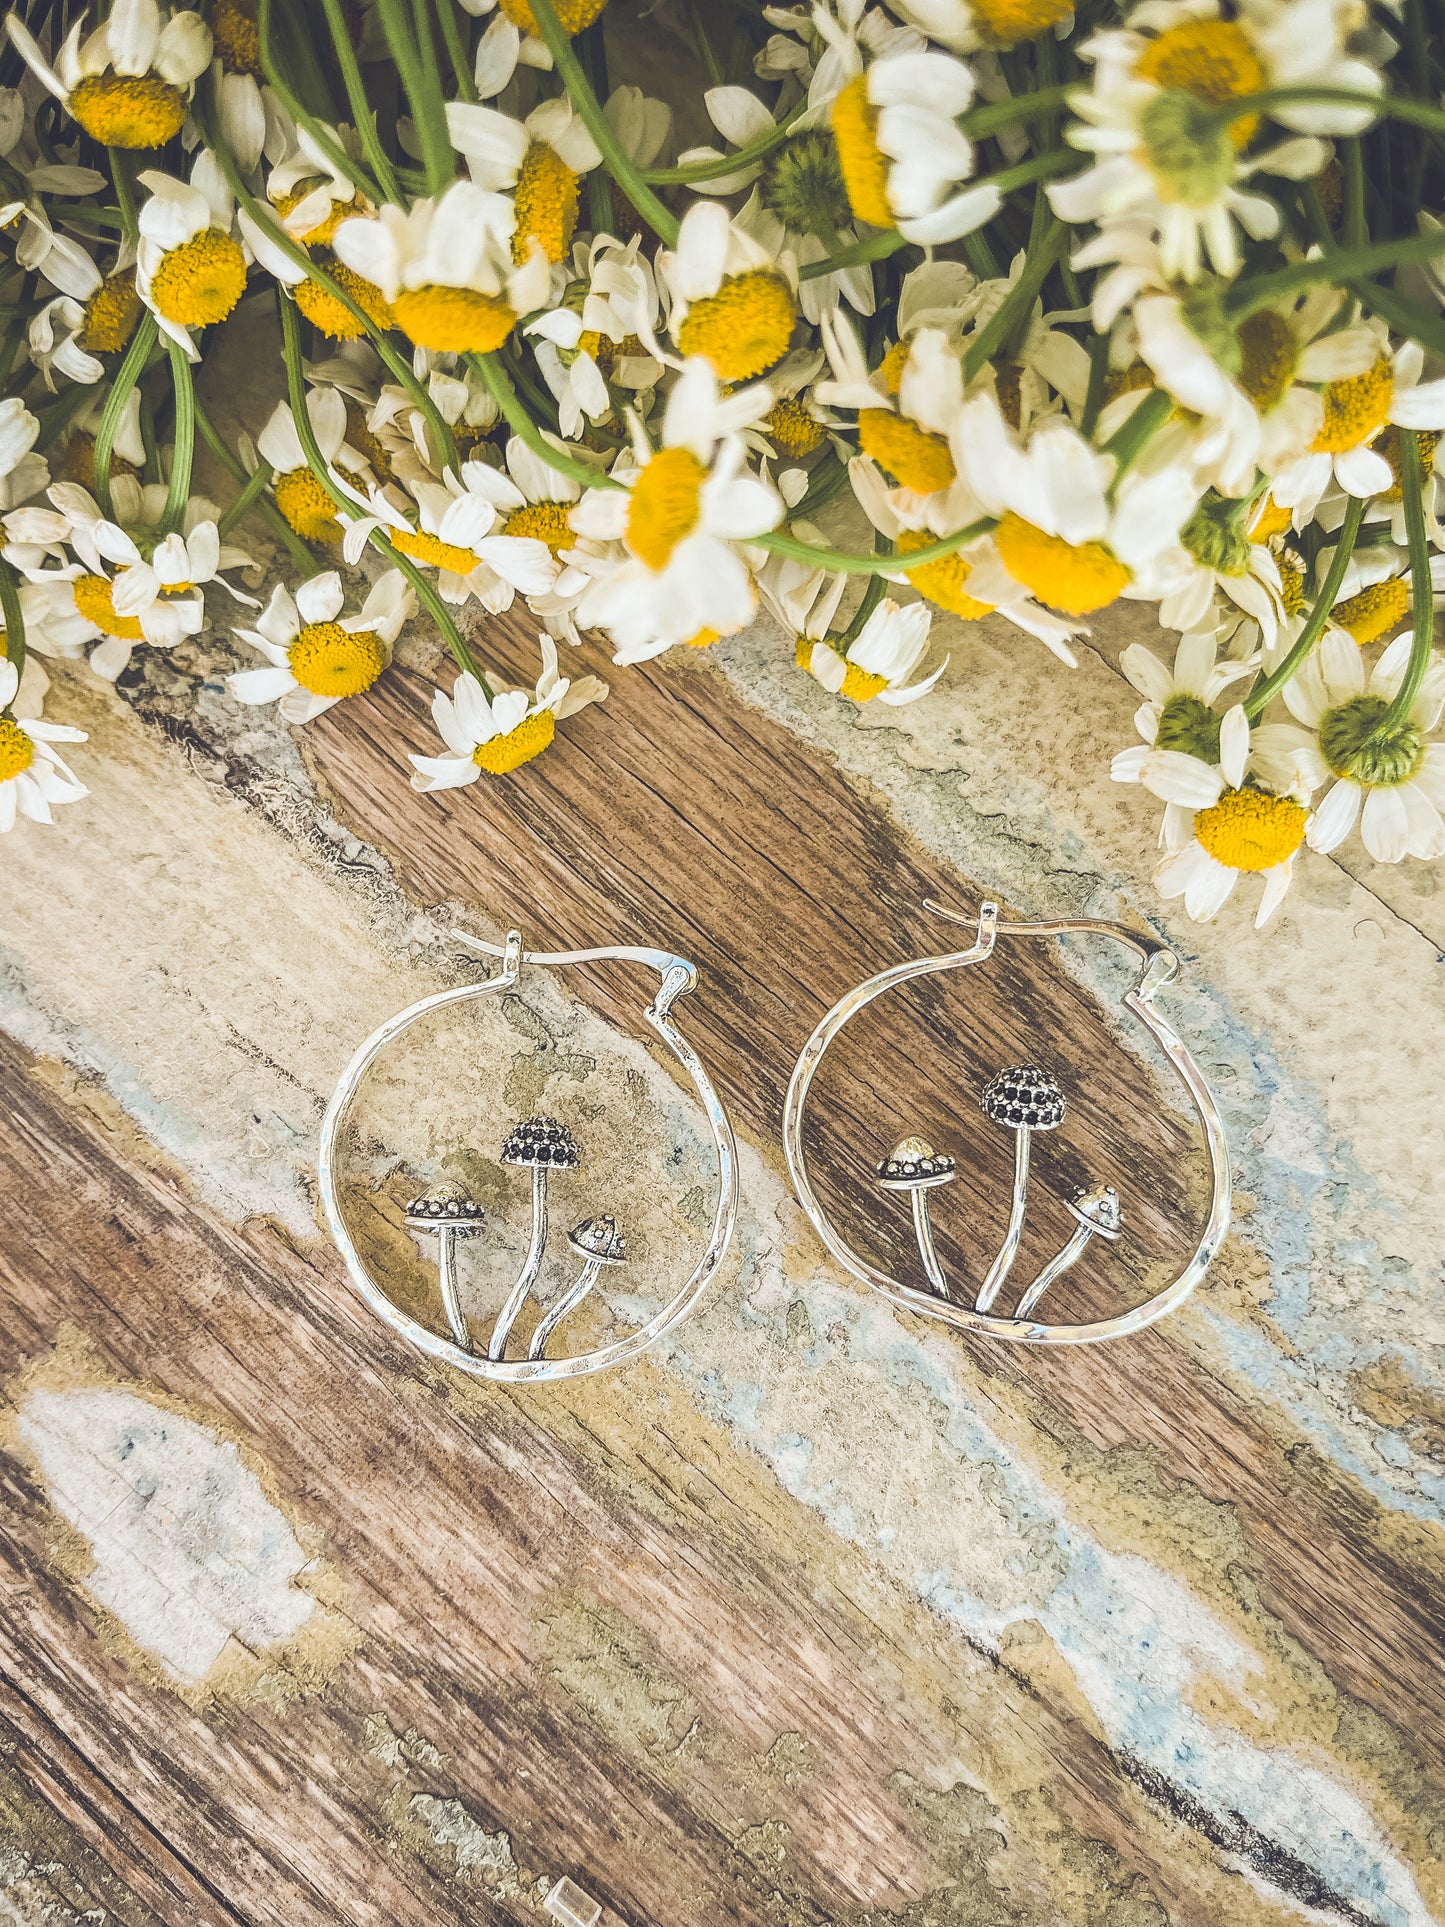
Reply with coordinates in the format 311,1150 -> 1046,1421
782,904 -> 1229,1345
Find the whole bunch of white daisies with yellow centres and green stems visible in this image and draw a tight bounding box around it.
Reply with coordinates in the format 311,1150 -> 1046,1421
0,0 -> 1445,921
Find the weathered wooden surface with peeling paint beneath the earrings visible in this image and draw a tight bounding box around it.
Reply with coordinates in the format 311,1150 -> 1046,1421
0,398 -> 1445,1927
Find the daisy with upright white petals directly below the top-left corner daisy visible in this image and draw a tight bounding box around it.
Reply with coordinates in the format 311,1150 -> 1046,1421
135,150 -> 247,360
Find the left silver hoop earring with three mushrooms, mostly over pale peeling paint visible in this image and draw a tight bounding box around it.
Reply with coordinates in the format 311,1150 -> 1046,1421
318,931 -> 738,1386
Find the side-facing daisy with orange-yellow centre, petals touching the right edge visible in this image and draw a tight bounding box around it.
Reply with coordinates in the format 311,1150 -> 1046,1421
1270,320 -> 1445,526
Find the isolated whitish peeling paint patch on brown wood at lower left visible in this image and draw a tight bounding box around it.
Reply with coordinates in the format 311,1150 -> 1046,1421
17,1387 -> 316,1686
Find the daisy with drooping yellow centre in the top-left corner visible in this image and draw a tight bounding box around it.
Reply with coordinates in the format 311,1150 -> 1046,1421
6,0 -> 210,148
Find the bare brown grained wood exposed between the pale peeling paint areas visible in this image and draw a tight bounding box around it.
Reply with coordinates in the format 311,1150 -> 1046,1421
0,601 -> 1445,1927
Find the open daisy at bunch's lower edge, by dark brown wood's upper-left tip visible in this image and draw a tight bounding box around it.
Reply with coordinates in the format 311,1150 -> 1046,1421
225,568 -> 416,723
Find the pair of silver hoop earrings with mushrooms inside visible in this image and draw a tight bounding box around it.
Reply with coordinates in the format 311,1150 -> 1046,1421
318,904 -> 1229,1384
